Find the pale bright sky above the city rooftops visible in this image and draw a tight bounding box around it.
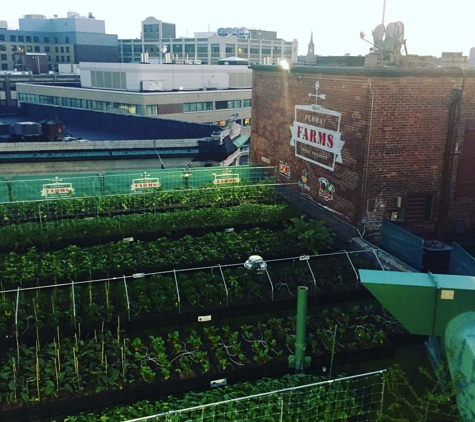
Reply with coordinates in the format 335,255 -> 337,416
0,0 -> 475,57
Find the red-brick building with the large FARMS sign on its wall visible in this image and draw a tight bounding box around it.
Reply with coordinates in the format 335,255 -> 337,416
250,66 -> 475,240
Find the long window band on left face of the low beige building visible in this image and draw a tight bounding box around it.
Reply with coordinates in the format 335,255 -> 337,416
18,93 -> 142,114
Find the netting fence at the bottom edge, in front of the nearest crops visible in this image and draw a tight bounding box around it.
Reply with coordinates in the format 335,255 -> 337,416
122,370 -> 385,422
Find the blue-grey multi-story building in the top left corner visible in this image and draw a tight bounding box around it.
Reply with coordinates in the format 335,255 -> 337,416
0,12 -> 119,73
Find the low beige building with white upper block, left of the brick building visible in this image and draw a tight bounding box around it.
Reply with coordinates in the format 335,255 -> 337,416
17,63 -> 252,125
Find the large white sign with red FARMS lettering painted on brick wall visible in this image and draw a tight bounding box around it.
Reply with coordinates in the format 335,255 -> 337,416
290,81 -> 345,171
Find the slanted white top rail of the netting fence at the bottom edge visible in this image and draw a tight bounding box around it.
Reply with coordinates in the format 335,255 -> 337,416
125,369 -> 386,422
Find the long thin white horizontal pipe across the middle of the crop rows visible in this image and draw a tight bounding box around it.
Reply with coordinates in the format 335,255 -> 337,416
0,249 -> 376,294
